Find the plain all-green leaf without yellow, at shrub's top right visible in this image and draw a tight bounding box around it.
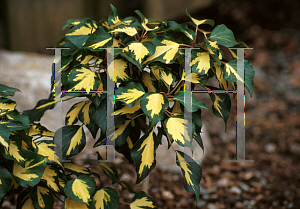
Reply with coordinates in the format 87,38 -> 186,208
210,24 -> 238,47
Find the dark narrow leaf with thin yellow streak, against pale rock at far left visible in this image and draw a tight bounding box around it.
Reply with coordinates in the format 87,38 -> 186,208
22,99 -> 55,123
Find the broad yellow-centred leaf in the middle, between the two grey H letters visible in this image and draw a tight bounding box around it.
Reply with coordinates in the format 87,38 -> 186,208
141,92 -> 169,129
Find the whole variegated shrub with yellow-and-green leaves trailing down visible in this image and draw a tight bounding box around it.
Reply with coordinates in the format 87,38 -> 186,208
0,6 -> 254,209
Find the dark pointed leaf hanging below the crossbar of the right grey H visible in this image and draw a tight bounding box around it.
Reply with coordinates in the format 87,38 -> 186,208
204,86 -> 231,131
